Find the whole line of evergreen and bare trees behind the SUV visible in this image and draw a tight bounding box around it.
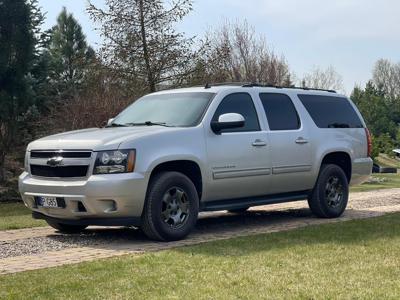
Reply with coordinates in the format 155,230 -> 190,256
0,0 -> 400,185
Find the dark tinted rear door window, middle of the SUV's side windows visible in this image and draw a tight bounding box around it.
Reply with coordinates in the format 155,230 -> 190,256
260,93 -> 300,130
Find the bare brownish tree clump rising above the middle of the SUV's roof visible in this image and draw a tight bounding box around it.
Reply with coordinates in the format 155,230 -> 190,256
194,21 -> 291,86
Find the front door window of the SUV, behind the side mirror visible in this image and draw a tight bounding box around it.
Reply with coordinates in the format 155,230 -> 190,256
212,93 -> 260,132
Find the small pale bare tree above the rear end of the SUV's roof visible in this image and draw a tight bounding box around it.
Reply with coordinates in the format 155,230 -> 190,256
301,66 -> 344,91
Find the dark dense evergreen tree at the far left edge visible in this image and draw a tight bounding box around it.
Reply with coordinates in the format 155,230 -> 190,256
0,0 -> 36,181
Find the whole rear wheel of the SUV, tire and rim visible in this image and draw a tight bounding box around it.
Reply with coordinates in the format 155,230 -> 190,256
308,164 -> 349,218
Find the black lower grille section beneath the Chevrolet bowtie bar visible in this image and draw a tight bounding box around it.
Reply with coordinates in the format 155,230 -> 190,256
31,165 -> 88,178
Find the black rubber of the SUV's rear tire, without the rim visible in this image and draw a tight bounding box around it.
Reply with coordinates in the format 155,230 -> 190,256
315,165 -> 349,218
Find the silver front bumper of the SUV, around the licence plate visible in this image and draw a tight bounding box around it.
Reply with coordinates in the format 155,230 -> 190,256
19,172 -> 147,225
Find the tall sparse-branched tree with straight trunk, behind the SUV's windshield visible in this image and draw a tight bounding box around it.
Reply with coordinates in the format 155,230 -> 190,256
87,0 -> 193,92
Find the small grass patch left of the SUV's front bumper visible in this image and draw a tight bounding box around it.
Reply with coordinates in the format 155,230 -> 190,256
0,203 -> 47,230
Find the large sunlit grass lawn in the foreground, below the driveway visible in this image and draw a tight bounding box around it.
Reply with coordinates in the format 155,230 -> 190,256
0,214 -> 400,299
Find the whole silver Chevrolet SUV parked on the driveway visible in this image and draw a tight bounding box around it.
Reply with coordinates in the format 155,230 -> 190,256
19,84 -> 372,241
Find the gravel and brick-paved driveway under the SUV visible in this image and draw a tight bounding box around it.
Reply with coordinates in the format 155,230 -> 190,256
0,189 -> 400,274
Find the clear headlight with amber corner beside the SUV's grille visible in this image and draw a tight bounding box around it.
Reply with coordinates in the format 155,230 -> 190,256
93,150 -> 136,174
